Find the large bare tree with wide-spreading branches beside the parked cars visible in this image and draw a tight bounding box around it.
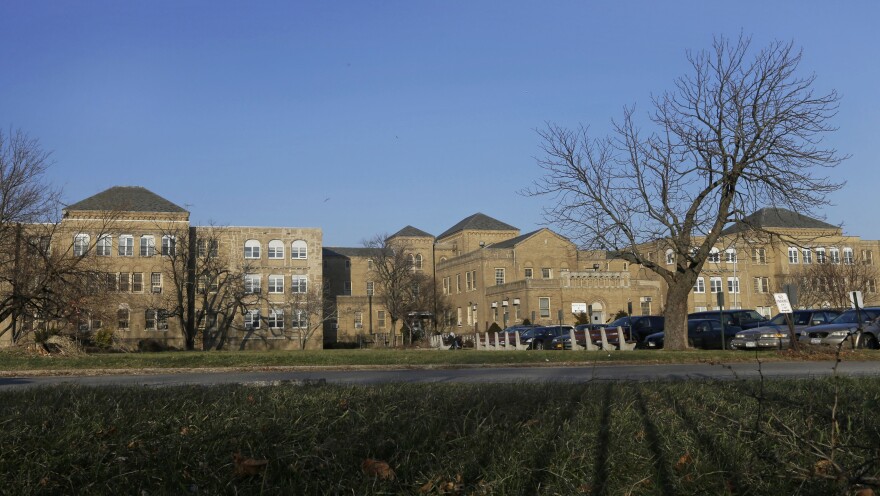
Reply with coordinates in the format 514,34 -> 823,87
526,37 -> 845,349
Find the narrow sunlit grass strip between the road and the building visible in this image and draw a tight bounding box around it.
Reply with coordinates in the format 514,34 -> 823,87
0,349 -> 880,372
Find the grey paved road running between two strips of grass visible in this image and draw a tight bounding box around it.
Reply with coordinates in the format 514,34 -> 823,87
0,361 -> 880,391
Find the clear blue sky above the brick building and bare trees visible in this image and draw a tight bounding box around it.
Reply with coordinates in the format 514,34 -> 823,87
0,0 -> 880,246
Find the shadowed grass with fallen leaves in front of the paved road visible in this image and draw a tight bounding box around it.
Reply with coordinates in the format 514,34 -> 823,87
0,378 -> 880,495
